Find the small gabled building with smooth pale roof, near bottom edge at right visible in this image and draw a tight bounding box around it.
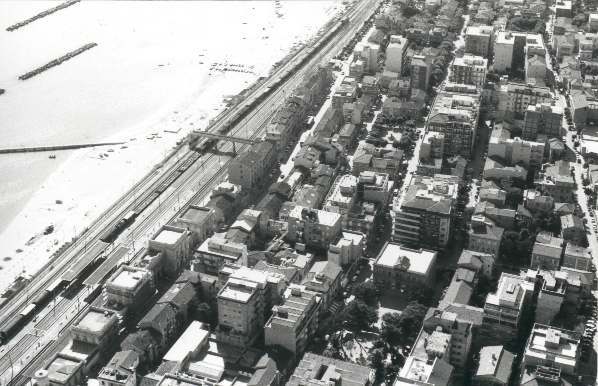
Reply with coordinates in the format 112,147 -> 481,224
472,346 -> 515,386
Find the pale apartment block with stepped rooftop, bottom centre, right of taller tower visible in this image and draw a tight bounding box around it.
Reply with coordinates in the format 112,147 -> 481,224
264,285 -> 320,357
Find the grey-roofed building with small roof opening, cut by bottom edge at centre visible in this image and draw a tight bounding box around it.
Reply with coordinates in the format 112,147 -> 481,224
287,353 -> 374,386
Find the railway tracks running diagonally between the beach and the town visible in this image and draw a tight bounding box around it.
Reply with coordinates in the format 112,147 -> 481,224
0,0 -> 378,384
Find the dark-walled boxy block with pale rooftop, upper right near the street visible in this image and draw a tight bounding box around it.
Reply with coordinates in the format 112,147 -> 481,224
523,103 -> 563,140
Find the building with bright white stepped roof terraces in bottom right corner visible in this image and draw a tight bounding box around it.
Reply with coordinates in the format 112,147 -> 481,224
523,323 -> 581,375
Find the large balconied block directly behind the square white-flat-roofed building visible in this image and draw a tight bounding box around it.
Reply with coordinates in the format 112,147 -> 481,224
391,174 -> 460,249
